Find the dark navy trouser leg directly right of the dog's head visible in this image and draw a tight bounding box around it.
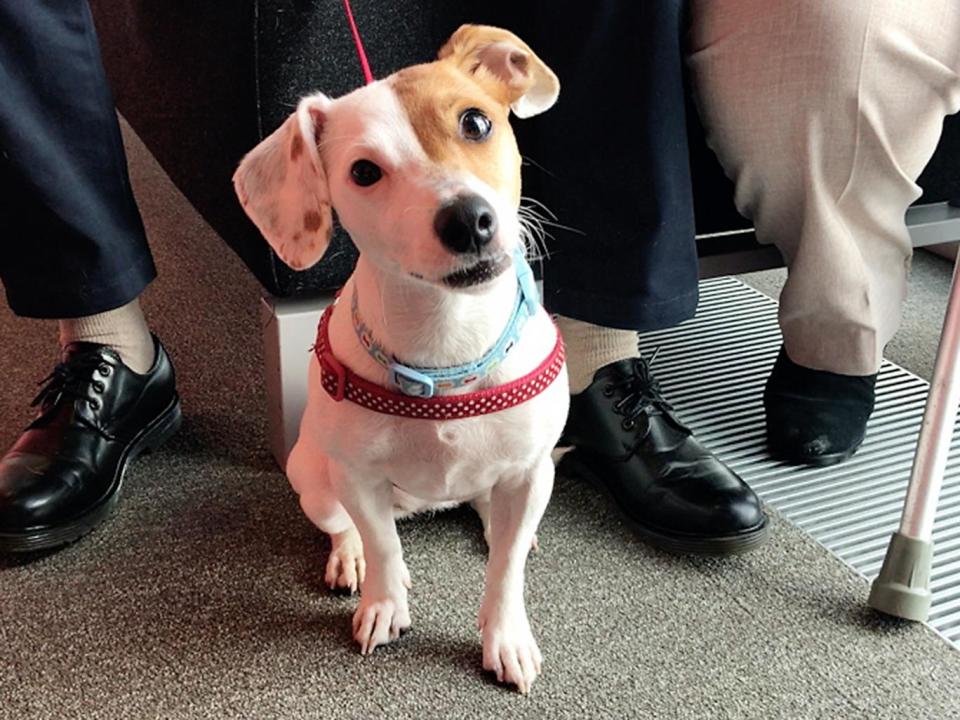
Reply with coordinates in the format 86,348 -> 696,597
516,0 -> 698,330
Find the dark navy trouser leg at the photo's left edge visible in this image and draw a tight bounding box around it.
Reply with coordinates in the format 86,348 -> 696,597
0,0 -> 156,318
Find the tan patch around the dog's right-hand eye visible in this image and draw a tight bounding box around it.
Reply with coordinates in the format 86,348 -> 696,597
390,62 -> 520,205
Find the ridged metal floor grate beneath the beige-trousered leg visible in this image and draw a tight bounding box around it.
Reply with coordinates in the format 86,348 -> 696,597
640,278 -> 960,645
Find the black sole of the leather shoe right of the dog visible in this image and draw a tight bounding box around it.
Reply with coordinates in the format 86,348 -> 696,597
557,449 -> 770,555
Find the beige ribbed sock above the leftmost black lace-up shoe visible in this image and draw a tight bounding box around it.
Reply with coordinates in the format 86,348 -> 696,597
60,300 -> 156,374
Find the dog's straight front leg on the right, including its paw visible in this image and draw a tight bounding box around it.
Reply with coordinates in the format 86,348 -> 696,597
480,455 -> 554,693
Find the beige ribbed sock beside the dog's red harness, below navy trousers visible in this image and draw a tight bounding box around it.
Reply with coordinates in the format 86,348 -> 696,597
557,315 -> 640,395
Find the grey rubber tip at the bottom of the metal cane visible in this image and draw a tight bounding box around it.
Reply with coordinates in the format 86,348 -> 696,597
867,532 -> 933,622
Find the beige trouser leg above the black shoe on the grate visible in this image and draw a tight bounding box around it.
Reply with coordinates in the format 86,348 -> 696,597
689,0 -> 960,375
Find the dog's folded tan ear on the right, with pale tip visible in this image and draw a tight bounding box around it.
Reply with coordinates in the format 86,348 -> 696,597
438,25 -> 560,118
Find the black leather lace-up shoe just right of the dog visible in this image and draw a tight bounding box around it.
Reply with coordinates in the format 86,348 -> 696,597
558,358 -> 767,554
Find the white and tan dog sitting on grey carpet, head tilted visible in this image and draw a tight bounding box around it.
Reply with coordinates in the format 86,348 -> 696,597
234,25 -> 569,692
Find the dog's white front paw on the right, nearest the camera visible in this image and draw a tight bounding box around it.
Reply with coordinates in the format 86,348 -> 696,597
480,608 -> 543,693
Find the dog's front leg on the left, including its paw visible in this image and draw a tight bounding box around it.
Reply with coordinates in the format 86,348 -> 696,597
330,466 -> 410,655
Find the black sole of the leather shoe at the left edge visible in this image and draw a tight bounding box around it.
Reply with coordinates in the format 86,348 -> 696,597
0,393 -> 183,553
